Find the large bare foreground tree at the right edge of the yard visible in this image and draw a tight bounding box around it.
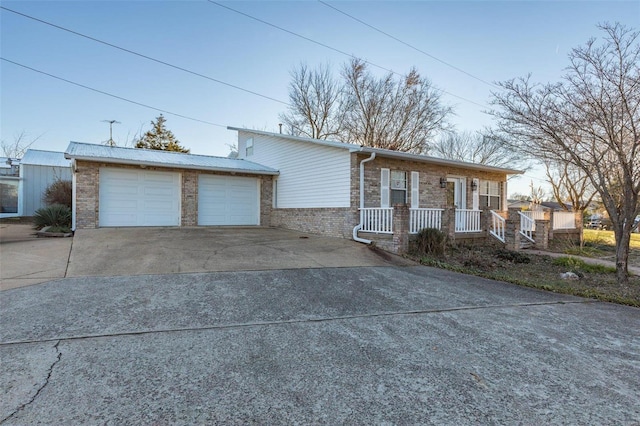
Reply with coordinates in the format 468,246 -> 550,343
492,24 -> 640,286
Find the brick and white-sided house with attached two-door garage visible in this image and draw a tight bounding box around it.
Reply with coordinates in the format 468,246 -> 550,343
65,131 -> 584,252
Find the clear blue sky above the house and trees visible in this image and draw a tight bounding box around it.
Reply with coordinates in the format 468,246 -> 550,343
0,0 -> 640,193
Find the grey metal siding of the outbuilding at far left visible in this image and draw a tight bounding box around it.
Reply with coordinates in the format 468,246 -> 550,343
20,164 -> 71,216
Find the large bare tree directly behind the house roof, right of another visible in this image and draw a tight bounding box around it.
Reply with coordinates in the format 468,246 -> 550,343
343,59 -> 452,153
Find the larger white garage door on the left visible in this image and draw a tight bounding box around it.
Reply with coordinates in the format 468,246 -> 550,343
99,168 -> 180,226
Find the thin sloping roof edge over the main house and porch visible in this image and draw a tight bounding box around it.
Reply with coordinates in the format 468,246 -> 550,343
227,127 -> 524,175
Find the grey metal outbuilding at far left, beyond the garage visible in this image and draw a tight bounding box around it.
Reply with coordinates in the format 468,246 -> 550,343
0,149 -> 71,217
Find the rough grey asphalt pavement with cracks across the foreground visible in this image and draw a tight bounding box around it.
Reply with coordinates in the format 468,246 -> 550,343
0,266 -> 640,425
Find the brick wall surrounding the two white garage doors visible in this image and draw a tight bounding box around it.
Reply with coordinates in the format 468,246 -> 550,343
76,161 -> 273,229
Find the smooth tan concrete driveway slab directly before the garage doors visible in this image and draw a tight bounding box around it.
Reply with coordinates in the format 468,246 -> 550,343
66,227 -> 412,277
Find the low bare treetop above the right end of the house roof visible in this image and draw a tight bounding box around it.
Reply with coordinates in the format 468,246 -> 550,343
428,131 -> 526,168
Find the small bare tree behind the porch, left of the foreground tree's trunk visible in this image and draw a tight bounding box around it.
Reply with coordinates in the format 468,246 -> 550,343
545,161 -> 596,212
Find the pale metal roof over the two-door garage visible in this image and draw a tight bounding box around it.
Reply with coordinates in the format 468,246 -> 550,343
64,142 -> 278,175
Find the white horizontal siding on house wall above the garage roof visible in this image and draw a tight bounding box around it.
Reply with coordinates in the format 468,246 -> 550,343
238,132 -> 351,208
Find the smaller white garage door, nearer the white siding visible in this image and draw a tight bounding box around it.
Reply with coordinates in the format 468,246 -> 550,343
198,175 -> 260,225
